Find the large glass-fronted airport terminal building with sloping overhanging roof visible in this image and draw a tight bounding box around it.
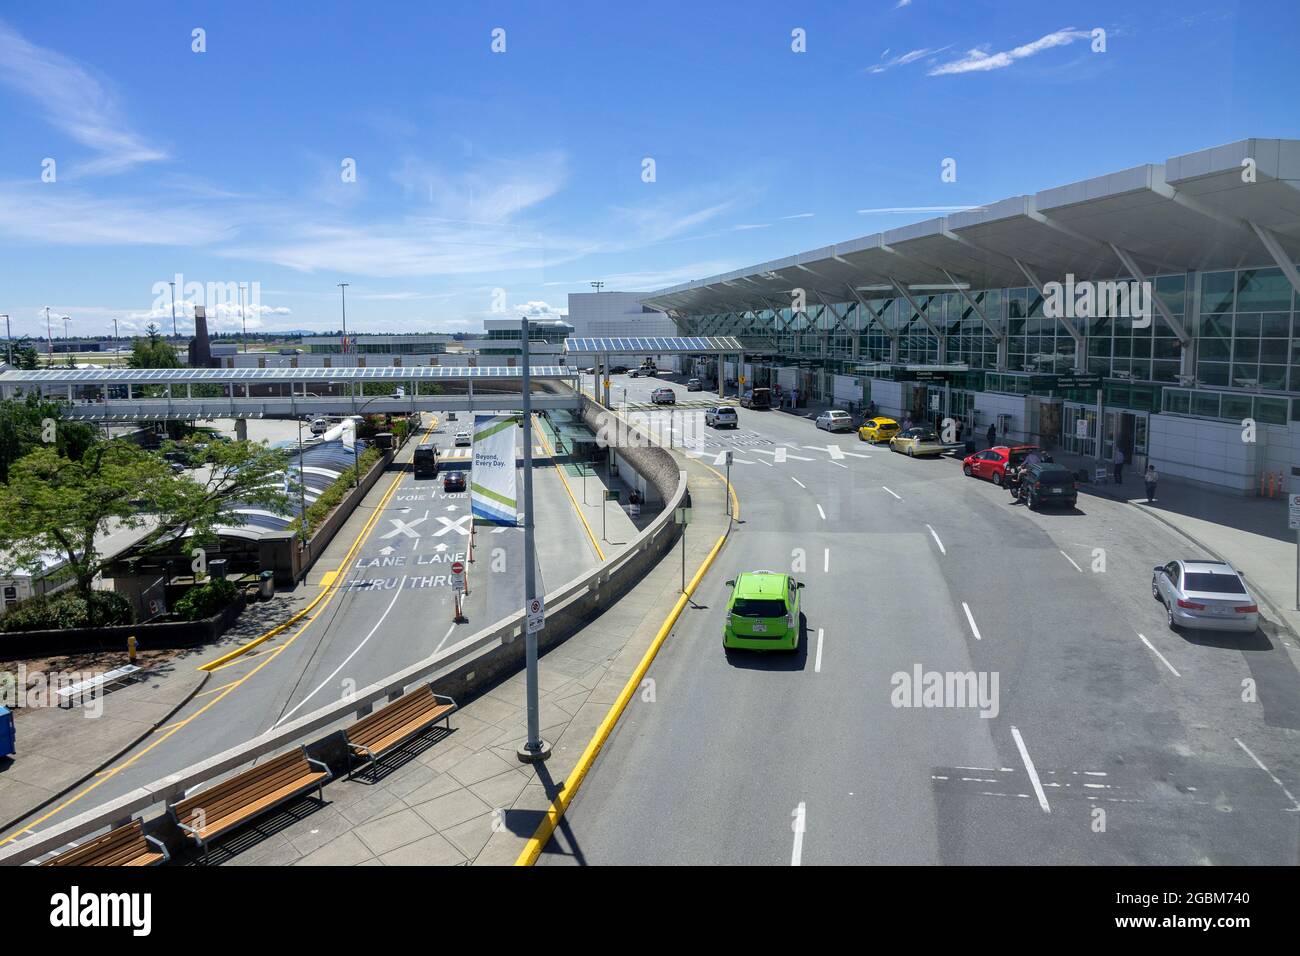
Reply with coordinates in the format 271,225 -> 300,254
641,139 -> 1300,493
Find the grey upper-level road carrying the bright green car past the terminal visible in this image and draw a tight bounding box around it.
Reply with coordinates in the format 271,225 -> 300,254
541,380 -> 1300,865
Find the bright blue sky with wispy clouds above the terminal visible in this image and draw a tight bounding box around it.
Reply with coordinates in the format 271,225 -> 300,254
0,0 -> 1300,336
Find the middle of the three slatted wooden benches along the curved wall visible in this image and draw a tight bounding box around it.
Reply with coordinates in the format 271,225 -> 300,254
168,747 -> 330,862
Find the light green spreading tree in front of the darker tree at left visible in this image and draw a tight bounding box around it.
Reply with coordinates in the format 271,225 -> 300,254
0,440 -> 293,629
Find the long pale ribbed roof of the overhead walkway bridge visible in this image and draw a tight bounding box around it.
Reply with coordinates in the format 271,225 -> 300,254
0,365 -> 573,385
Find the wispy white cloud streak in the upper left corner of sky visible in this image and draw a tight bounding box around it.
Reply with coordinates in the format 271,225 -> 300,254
0,22 -> 166,176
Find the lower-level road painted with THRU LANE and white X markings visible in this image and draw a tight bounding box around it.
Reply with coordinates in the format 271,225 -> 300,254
12,411 -> 597,827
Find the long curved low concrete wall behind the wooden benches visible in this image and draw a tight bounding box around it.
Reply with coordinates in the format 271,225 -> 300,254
0,426 -> 686,866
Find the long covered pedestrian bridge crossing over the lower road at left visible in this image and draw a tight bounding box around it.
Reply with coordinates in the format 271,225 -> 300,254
0,365 -> 581,421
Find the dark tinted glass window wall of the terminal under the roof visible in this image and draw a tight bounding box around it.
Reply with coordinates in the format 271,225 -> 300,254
680,267 -> 1300,421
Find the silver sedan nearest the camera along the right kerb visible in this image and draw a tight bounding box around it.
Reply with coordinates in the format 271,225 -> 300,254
1151,561 -> 1260,632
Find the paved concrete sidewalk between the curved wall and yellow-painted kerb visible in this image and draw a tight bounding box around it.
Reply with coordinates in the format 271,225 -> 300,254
212,453 -> 728,866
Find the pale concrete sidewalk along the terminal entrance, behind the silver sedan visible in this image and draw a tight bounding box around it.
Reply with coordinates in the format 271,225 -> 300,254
1053,451 -> 1300,635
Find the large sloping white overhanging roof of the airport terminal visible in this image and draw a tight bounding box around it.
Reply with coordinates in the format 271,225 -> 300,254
641,139 -> 1300,316
